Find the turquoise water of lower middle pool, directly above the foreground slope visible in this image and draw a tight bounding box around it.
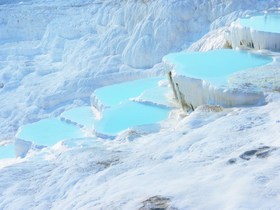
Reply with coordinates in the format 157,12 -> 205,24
95,101 -> 170,135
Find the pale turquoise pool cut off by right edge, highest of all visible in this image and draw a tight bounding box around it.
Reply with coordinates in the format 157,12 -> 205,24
239,13 -> 280,33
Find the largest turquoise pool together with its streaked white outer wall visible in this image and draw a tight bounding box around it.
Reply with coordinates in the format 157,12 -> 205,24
163,49 -> 273,110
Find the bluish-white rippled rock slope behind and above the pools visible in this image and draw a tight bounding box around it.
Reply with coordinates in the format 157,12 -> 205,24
0,0 -> 279,140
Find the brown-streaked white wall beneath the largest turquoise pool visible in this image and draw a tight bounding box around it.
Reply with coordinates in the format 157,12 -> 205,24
167,75 -> 265,109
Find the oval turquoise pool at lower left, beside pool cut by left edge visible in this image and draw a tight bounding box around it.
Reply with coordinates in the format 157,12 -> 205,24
17,118 -> 84,146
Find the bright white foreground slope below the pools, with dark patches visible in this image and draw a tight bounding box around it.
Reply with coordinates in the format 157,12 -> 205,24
0,94 -> 280,209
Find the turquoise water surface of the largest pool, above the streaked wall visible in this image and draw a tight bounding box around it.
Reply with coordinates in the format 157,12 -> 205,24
164,49 -> 272,84
